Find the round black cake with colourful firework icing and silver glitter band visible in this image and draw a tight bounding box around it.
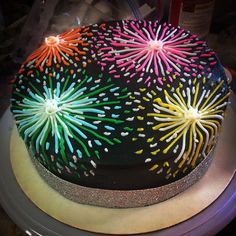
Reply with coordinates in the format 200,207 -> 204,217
11,20 -> 229,207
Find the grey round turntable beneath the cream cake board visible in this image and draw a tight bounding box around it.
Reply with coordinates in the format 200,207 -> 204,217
0,107 -> 236,236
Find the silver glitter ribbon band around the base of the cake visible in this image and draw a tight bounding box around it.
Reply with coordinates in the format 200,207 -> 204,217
32,150 -> 214,208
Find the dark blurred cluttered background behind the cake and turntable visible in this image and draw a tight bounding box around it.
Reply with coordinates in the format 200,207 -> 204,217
0,0 -> 236,236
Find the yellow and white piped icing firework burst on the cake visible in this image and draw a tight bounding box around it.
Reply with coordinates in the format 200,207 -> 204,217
133,76 -> 229,179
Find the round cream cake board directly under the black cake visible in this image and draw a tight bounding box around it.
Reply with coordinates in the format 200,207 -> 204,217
10,108 -> 236,234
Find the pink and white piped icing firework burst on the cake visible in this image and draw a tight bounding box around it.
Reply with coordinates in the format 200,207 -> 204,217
97,21 -> 216,86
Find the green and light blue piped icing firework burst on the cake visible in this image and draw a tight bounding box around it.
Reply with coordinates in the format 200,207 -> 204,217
12,70 -> 132,177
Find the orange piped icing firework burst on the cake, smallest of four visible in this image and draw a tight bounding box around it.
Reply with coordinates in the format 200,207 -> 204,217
23,28 -> 92,71
